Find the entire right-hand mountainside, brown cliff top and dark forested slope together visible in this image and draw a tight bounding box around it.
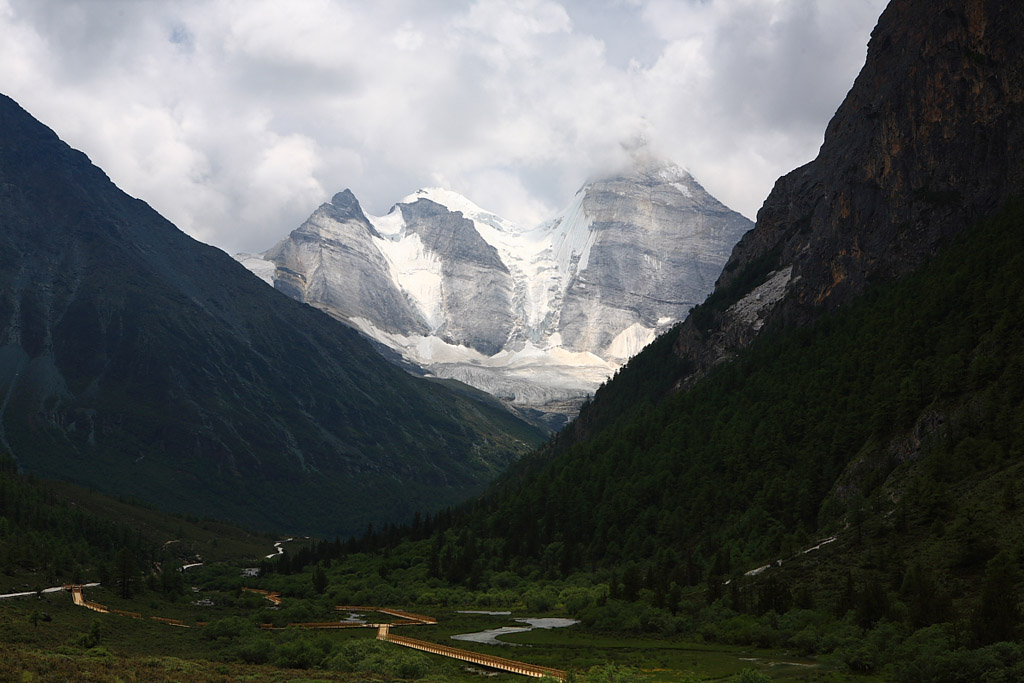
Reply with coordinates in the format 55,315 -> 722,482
350,0 -> 1024,681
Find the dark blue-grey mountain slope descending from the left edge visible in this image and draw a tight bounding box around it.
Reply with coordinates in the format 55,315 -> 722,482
0,92 -> 539,535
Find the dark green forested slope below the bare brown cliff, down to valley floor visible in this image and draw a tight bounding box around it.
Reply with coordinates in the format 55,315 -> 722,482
321,198 -> 1024,680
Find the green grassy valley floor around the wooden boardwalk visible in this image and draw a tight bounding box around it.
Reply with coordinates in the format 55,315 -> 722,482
0,569 -> 874,683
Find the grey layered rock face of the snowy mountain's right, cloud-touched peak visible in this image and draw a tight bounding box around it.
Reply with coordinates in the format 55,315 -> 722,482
559,165 -> 750,361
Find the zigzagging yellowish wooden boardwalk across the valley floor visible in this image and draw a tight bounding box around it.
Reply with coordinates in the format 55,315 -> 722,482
63,585 -> 565,681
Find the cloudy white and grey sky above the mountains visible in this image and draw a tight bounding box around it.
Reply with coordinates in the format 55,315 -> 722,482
0,0 -> 886,253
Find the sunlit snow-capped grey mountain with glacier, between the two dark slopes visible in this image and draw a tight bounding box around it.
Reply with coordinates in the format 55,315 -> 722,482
237,161 -> 752,415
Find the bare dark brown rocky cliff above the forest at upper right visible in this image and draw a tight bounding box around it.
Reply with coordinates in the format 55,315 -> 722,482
677,0 -> 1024,368
